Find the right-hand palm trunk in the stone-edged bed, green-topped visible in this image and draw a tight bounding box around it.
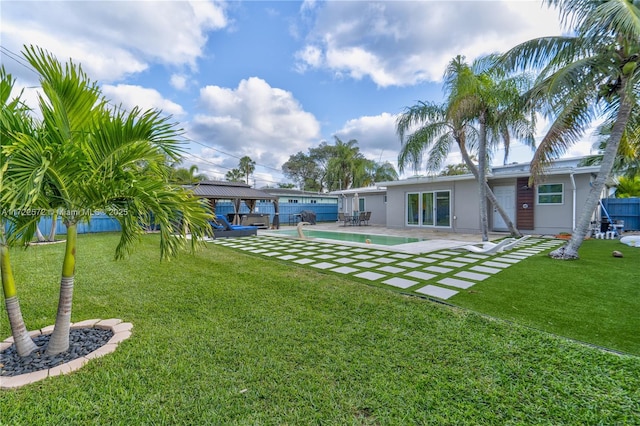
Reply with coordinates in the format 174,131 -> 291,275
46,223 -> 78,355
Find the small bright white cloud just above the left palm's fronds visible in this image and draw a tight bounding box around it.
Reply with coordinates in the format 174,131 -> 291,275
102,84 -> 185,117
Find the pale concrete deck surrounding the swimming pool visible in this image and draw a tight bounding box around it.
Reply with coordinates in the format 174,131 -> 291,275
258,222 -> 509,253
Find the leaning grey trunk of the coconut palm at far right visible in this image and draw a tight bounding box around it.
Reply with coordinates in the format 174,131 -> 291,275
549,89 -> 633,260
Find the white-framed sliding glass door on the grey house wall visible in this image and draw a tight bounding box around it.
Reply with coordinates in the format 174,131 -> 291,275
406,191 -> 451,227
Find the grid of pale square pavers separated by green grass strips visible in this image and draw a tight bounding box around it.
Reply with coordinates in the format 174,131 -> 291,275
212,234 -> 563,300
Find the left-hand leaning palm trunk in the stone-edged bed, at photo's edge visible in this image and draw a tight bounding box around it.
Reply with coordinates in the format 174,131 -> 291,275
0,243 -> 38,356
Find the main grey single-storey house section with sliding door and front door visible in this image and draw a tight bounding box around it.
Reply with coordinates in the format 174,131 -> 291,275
379,158 -> 599,234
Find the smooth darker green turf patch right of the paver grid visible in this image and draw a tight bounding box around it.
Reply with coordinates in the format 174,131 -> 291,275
450,240 -> 640,355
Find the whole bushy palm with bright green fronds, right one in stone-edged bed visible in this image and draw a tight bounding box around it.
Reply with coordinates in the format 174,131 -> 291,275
6,47 -> 210,354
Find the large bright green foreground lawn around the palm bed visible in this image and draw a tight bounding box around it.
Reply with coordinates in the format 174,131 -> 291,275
0,235 -> 640,425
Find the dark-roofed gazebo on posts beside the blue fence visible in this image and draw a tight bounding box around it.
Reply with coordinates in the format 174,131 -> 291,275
187,181 -> 280,229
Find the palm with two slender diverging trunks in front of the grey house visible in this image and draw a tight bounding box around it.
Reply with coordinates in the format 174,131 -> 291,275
396,56 -> 534,241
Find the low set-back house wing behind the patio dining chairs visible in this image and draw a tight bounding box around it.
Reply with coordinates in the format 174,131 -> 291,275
331,186 -> 387,225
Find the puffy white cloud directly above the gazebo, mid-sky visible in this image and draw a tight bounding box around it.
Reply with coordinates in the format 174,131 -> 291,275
189,77 -> 320,173
